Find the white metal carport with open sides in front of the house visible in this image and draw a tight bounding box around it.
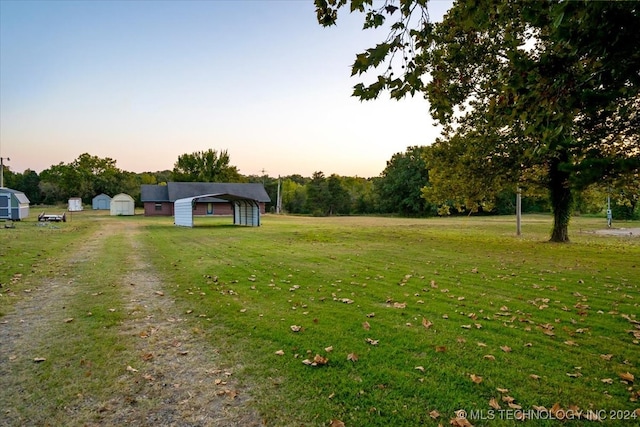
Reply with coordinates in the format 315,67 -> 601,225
173,193 -> 260,227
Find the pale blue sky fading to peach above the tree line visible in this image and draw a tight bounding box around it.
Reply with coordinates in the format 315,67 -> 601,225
0,0 -> 451,177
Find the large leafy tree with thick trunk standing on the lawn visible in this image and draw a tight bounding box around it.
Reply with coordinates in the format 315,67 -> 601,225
315,0 -> 640,242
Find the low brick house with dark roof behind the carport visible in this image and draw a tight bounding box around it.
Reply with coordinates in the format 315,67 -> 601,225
140,182 -> 271,216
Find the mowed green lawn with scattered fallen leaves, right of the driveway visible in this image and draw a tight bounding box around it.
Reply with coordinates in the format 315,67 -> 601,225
144,216 -> 640,426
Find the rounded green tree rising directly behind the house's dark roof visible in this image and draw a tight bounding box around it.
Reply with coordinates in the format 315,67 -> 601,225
173,149 -> 242,182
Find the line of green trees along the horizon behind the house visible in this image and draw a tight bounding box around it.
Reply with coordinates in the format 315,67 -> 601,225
4,146 -> 640,219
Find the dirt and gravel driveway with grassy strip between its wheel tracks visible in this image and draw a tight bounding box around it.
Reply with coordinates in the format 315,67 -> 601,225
0,219 -> 262,426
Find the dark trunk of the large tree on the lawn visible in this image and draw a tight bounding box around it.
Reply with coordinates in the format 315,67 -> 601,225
549,151 -> 573,243
